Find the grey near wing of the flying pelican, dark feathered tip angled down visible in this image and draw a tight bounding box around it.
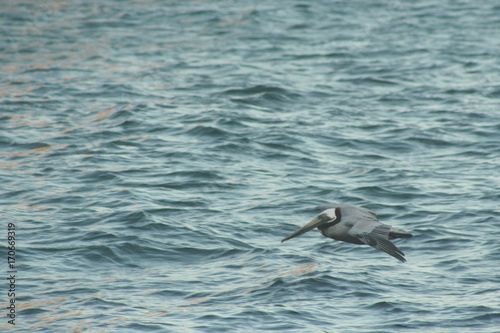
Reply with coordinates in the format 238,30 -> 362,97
349,219 -> 406,262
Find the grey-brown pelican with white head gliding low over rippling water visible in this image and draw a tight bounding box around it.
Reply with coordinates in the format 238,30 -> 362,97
281,205 -> 413,262
